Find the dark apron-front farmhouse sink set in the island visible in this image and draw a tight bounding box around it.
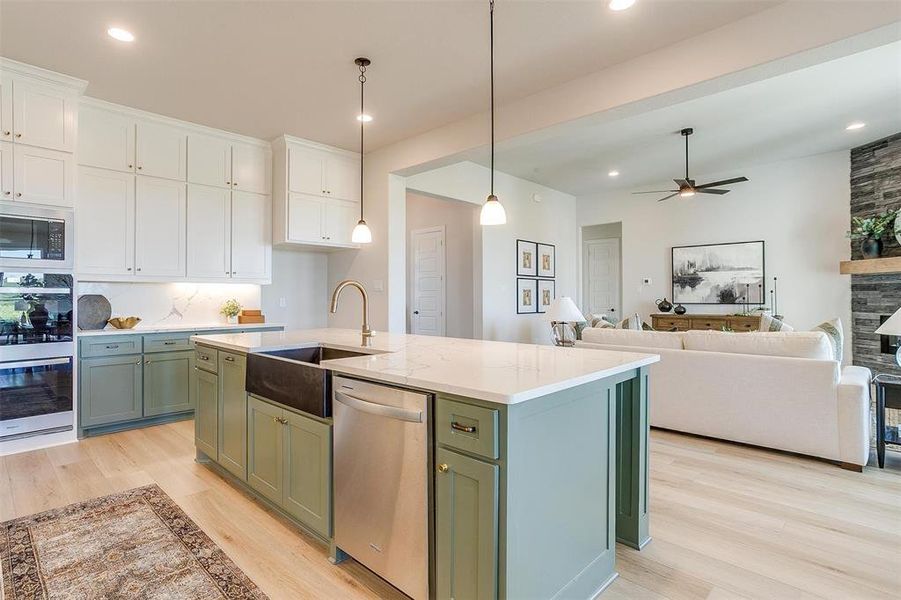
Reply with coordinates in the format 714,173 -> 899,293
245,346 -> 367,417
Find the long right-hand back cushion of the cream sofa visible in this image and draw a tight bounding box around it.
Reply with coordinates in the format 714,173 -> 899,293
682,331 -> 833,360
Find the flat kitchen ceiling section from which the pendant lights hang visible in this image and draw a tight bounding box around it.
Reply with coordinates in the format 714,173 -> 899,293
0,0 -> 776,149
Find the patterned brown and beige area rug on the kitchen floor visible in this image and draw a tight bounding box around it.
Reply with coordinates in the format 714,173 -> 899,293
0,485 -> 266,600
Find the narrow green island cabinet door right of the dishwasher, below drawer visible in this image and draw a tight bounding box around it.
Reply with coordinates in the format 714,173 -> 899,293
435,448 -> 498,600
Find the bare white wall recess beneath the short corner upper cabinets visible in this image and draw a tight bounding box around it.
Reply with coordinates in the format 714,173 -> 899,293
262,248 -> 329,329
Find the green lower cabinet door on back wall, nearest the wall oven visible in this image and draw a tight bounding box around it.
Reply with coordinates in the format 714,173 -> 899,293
79,354 -> 143,427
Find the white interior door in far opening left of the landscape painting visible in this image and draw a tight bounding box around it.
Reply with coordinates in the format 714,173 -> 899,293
582,238 -> 622,322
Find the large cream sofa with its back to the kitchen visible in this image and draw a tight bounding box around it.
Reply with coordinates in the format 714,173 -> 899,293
577,328 -> 870,470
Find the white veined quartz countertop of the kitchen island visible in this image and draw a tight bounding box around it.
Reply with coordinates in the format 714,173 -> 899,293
191,329 -> 660,404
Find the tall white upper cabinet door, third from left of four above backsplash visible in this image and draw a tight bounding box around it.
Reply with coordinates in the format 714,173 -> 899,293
187,183 -> 232,279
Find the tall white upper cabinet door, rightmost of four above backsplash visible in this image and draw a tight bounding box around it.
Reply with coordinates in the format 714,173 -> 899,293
231,192 -> 272,280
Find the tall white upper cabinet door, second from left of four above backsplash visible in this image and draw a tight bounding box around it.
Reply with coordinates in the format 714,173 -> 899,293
135,177 -> 187,280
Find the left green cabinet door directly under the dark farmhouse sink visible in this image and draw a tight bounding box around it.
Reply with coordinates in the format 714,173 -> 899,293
247,396 -> 285,505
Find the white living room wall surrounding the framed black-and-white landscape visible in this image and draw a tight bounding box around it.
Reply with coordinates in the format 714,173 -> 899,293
578,152 -> 851,359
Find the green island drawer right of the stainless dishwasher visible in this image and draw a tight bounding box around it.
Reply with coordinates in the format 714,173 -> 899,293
435,396 -> 500,459
